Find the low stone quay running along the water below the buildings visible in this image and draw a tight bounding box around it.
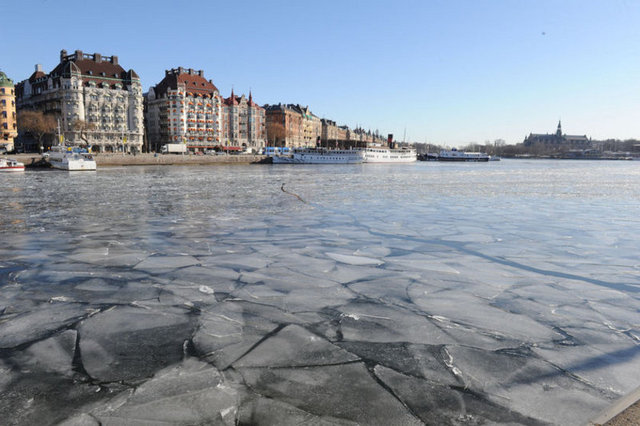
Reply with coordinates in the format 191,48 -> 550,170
7,153 -> 268,167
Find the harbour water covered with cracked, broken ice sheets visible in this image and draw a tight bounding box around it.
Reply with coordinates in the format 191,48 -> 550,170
0,160 -> 640,425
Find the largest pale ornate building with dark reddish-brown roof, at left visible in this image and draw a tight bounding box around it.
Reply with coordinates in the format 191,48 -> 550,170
16,50 -> 144,152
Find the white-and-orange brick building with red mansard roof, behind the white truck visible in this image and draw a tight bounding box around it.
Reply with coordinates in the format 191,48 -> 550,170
145,67 -> 222,152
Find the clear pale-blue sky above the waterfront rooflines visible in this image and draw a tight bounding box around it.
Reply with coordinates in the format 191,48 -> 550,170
0,0 -> 640,146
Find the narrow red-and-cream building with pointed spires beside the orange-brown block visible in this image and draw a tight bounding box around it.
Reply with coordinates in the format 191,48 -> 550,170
222,89 -> 266,152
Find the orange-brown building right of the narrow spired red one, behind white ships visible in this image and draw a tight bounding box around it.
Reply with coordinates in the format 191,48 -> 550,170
265,104 -> 322,148
